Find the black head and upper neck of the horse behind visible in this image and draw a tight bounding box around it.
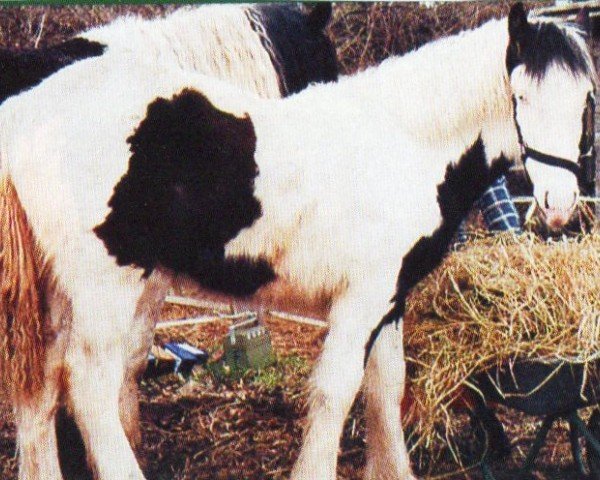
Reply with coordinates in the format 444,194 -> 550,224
253,4 -> 338,95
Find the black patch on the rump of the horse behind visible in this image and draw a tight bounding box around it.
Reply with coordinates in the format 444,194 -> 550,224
0,38 -> 106,103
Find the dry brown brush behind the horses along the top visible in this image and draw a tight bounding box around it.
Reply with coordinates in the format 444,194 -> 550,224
0,0 -> 524,73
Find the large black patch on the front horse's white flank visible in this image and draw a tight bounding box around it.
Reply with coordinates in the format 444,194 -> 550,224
94,90 -> 275,295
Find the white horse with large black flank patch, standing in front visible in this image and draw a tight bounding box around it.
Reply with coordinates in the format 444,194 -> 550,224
0,4 -> 596,480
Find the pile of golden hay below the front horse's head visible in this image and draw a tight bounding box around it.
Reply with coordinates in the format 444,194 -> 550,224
405,234 -> 600,458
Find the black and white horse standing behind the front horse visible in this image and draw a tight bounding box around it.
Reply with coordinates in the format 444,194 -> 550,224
0,3 -> 337,479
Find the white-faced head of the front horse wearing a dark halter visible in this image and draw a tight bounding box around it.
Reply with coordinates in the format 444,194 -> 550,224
506,3 -> 596,230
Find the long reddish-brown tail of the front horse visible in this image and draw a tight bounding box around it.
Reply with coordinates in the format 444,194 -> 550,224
0,176 -> 46,402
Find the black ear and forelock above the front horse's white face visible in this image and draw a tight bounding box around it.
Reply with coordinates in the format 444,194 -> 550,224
506,3 -> 590,80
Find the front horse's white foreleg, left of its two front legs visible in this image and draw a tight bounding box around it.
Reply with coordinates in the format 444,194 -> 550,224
291,281 -> 393,480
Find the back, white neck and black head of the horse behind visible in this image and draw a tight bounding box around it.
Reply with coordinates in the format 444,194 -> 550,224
0,3 -> 338,103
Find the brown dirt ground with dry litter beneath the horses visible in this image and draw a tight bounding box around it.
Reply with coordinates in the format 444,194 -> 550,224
0,306 -> 596,480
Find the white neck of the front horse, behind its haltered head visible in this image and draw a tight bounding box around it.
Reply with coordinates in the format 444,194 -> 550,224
346,20 -> 516,158
